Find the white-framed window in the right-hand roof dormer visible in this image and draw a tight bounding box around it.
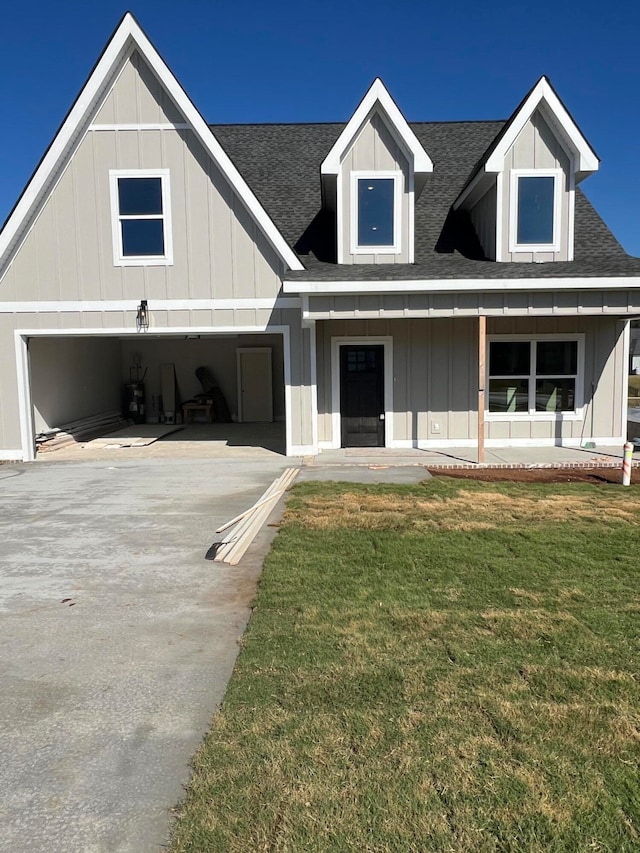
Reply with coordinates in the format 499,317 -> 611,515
509,169 -> 562,252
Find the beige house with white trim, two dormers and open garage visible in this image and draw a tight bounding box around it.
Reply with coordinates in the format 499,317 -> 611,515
0,14 -> 640,460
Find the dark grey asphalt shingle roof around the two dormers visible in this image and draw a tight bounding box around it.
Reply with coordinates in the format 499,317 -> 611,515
211,121 -> 640,282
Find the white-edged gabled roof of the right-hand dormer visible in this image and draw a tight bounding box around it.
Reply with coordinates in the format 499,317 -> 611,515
453,76 -> 600,209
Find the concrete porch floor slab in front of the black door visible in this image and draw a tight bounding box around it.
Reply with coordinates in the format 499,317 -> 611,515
304,444 -> 640,468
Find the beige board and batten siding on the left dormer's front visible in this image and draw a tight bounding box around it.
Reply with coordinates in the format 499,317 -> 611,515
339,112 -> 409,264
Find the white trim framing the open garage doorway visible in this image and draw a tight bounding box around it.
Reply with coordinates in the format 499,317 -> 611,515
14,325 -> 303,462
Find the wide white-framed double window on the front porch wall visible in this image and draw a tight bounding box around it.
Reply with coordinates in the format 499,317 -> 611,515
488,337 -> 580,417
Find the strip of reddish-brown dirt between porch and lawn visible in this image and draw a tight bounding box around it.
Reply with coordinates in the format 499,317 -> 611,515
427,468 -> 628,485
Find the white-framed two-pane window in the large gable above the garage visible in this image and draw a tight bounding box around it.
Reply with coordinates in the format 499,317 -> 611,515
110,169 -> 173,266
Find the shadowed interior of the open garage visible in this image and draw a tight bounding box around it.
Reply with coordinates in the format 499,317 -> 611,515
29,334 -> 286,455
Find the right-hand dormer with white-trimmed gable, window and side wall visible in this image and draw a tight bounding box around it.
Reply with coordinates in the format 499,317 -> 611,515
453,77 -> 599,263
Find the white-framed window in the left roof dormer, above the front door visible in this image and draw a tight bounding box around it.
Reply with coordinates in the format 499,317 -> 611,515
351,172 -> 402,254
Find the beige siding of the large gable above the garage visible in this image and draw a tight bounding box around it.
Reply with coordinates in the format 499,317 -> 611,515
0,49 -> 284,301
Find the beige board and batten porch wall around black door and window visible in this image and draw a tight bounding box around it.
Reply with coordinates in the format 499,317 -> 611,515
316,317 -> 626,446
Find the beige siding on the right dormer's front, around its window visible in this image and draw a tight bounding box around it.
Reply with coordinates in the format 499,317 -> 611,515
497,110 -> 571,263
